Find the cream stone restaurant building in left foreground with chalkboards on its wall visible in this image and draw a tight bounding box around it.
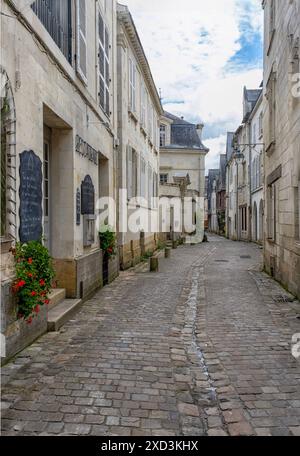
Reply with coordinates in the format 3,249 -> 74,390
1,0 -> 117,356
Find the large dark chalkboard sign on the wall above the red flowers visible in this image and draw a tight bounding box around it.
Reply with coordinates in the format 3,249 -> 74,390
19,150 -> 43,242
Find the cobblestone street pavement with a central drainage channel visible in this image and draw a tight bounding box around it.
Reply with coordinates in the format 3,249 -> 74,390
1,237 -> 300,436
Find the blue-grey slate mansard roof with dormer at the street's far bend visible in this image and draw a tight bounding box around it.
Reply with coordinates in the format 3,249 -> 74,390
164,111 -> 209,152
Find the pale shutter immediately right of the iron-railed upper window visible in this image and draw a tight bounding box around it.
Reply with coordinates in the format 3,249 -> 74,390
76,0 -> 87,84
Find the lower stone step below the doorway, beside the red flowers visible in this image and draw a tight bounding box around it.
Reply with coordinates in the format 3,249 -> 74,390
48,299 -> 82,332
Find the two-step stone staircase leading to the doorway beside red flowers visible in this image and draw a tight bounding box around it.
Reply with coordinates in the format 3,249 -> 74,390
47,288 -> 82,332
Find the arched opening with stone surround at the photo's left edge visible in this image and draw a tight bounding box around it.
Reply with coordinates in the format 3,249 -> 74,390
0,65 -> 17,241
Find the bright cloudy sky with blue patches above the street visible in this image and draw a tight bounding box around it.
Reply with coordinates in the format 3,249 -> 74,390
121,0 -> 263,173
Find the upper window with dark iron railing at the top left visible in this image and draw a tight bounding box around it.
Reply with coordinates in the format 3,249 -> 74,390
31,0 -> 72,63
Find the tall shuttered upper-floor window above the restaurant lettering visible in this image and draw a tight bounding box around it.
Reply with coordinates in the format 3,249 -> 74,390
98,12 -> 110,116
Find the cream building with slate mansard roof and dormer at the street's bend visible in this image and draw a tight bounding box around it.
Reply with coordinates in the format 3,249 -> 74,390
160,111 -> 209,242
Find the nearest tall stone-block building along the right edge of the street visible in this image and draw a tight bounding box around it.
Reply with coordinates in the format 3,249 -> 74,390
263,0 -> 300,296
